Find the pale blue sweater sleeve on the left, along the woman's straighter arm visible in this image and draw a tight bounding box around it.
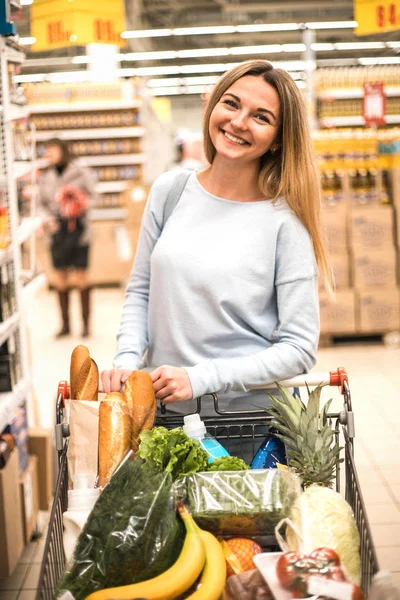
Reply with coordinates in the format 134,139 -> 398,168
114,171 -> 184,370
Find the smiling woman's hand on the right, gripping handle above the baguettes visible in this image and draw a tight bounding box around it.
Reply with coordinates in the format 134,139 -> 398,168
150,365 -> 193,404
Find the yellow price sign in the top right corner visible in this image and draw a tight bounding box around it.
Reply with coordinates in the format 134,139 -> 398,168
354,0 -> 400,35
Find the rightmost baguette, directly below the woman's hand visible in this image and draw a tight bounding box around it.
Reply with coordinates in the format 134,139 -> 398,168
124,371 -> 157,452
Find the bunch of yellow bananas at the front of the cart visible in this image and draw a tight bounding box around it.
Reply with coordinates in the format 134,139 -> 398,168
86,505 -> 226,600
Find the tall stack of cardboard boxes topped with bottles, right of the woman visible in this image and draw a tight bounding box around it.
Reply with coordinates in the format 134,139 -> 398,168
317,133 -> 400,336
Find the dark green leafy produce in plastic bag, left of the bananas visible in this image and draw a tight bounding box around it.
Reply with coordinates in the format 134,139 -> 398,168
57,457 -> 184,600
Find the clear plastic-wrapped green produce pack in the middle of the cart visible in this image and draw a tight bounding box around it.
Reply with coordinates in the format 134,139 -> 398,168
175,469 -> 301,536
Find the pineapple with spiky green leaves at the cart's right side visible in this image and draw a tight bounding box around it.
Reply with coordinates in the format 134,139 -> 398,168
267,383 -> 341,487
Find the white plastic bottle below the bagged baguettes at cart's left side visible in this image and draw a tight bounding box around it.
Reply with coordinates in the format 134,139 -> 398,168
63,473 -> 100,563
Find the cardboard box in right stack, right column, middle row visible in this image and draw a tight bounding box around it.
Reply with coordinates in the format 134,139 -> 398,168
351,247 -> 397,289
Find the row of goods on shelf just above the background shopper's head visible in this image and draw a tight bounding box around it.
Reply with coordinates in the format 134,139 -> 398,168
31,109 -> 140,131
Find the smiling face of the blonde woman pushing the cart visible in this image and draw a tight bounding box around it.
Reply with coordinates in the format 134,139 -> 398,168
209,75 -> 280,168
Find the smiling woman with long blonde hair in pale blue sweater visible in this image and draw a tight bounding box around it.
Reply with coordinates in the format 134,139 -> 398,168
102,60 -> 330,413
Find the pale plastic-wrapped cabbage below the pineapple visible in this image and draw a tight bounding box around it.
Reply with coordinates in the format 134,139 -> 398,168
286,485 -> 361,585
